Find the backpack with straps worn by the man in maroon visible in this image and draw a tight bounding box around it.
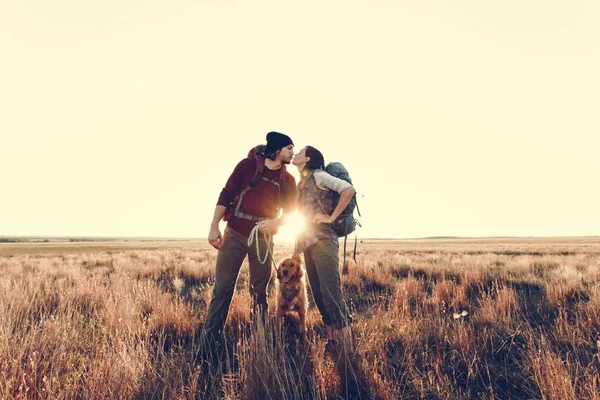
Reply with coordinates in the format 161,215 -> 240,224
223,144 -> 287,222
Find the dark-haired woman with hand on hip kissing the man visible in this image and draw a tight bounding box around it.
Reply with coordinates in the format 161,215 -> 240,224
292,146 -> 356,351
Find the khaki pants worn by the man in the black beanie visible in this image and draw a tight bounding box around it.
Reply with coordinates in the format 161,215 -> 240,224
202,228 -> 273,340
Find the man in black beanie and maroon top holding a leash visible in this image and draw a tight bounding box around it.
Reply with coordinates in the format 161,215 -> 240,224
202,132 -> 296,349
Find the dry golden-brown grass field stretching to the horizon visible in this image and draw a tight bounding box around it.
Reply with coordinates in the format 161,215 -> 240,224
0,238 -> 600,399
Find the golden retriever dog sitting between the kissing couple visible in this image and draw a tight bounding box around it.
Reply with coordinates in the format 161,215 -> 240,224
276,256 -> 308,340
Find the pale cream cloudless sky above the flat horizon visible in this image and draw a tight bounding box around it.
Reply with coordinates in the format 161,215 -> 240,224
0,0 -> 600,238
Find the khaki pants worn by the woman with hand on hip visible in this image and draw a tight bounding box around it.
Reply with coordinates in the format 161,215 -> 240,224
304,239 -> 352,328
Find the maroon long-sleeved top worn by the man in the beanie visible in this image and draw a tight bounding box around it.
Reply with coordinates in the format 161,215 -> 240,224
217,158 -> 296,236
